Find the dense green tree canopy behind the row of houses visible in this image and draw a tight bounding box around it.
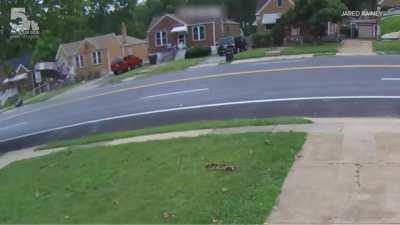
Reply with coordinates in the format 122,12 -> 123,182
0,0 -> 373,63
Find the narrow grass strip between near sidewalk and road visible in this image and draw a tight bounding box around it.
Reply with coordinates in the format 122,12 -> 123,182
38,117 -> 312,150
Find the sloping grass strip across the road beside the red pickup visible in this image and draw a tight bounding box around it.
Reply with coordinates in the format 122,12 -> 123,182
111,58 -> 204,82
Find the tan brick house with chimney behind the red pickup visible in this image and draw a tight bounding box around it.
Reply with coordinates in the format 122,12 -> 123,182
56,25 -> 148,79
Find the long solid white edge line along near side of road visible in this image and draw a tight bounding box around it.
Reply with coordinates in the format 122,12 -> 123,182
0,96 -> 400,143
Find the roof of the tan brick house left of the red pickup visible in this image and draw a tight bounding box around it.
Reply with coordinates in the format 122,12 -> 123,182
56,33 -> 146,58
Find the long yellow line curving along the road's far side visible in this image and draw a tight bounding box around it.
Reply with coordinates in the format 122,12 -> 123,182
0,65 -> 400,122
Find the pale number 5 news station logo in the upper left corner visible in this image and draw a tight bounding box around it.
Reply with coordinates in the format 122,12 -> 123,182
9,8 -> 40,39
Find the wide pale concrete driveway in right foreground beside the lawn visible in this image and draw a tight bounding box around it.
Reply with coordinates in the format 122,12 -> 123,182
268,119 -> 400,224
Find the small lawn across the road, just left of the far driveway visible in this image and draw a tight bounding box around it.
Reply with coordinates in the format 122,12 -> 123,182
281,43 -> 340,55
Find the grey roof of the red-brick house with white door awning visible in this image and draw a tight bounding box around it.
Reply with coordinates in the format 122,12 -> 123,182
148,6 -> 239,31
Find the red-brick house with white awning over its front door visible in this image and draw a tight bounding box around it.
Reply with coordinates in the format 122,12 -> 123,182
147,7 -> 242,53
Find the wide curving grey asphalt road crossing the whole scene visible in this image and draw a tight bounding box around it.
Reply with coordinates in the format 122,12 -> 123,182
0,56 -> 400,152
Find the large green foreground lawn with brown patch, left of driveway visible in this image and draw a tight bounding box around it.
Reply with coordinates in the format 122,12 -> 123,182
0,133 -> 306,224
